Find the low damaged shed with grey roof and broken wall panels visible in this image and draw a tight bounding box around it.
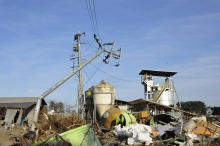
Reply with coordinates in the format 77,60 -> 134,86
0,97 -> 47,129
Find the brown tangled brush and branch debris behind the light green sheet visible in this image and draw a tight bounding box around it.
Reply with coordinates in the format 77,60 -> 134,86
6,112 -> 86,146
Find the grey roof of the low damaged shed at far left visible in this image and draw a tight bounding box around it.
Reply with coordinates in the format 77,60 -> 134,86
0,97 -> 47,108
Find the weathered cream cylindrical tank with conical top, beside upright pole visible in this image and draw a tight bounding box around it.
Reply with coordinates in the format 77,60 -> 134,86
92,80 -> 115,118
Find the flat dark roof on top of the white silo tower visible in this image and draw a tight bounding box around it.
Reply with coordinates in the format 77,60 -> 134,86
139,70 -> 177,77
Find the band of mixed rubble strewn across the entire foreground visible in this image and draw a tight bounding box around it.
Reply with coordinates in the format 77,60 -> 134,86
0,109 -> 220,146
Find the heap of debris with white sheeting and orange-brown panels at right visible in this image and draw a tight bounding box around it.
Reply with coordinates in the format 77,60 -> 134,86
99,112 -> 220,146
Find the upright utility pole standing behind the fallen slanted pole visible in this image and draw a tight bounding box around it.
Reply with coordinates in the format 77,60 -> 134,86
71,32 -> 85,117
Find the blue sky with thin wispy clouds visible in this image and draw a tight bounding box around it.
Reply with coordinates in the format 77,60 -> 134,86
0,0 -> 220,106
